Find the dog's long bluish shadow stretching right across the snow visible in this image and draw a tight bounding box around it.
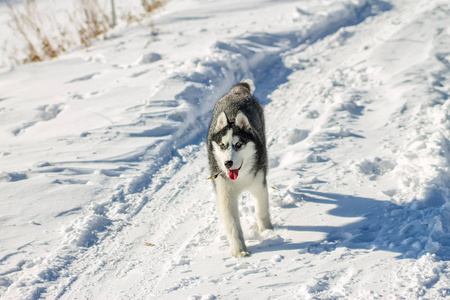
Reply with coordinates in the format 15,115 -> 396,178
249,190 -> 450,261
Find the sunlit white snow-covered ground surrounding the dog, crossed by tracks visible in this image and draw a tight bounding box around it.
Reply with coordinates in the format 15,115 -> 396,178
0,0 -> 450,299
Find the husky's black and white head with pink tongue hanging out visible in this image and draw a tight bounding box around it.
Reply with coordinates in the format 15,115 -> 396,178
212,111 -> 256,180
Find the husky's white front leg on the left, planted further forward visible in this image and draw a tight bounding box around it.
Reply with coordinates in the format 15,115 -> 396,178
216,178 -> 250,258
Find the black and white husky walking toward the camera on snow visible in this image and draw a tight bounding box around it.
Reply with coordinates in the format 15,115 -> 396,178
207,79 -> 273,257
